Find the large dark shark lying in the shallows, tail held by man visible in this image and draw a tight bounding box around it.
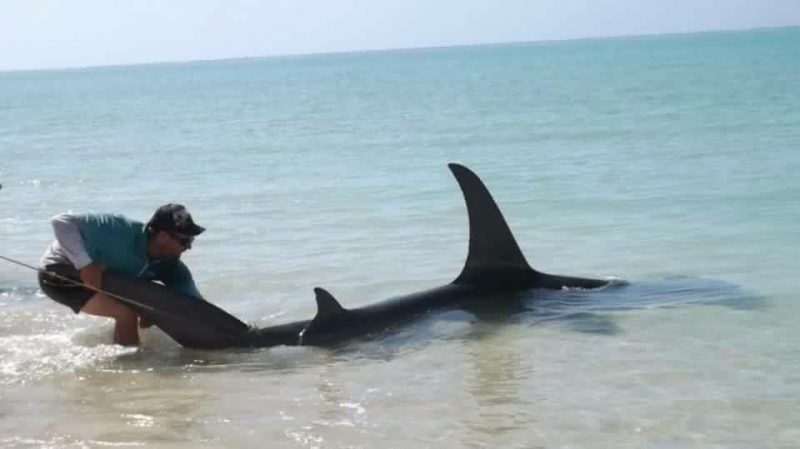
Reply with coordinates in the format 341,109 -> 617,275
103,164 -> 609,349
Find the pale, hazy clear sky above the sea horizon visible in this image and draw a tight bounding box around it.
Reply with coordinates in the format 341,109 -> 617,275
0,0 -> 800,70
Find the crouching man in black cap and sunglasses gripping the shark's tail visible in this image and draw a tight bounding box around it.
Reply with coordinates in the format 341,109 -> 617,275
39,203 -> 205,345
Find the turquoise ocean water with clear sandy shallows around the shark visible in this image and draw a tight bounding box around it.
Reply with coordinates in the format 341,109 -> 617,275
0,28 -> 800,449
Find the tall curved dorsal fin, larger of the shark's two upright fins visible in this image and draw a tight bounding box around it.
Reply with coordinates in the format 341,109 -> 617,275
448,164 -> 536,286
